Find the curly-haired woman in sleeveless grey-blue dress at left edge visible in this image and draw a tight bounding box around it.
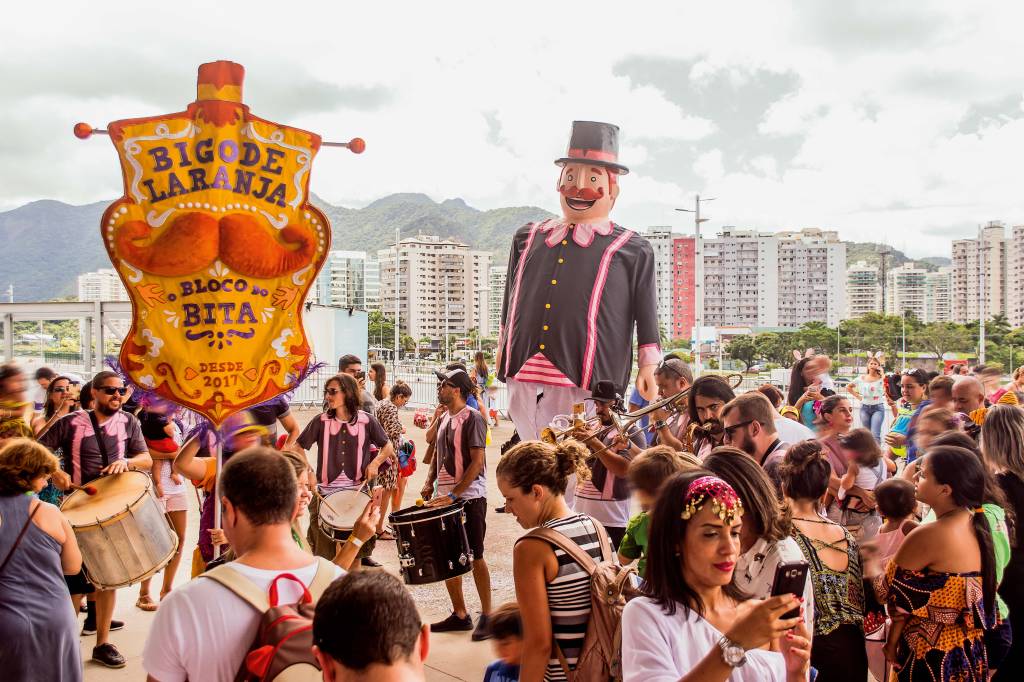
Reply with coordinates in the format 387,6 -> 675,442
0,438 -> 82,682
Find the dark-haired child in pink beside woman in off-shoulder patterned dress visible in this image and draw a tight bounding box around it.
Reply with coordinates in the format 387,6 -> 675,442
861,478 -> 918,680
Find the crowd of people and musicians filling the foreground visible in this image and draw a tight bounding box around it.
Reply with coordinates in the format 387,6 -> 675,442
6,353 -> 1024,682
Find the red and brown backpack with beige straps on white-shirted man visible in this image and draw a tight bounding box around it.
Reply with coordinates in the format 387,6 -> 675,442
200,557 -> 334,682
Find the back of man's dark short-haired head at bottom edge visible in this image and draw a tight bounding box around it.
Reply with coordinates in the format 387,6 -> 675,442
313,570 -> 430,682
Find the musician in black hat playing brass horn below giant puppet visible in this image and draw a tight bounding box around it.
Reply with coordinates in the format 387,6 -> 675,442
569,381 -> 647,550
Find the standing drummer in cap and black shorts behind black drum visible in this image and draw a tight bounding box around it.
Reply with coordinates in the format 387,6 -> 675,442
422,369 -> 490,641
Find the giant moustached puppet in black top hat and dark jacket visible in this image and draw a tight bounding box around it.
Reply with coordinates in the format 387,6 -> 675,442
498,121 -> 662,440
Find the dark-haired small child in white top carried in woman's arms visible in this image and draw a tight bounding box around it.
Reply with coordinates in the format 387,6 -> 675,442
836,428 -> 896,541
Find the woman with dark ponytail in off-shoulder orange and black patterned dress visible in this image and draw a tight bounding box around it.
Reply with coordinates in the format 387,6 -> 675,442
876,445 -> 998,682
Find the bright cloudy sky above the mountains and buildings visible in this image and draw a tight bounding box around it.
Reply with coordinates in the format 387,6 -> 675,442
0,0 -> 1024,256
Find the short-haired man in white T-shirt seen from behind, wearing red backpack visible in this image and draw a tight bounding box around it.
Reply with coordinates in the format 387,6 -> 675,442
142,447 -> 344,682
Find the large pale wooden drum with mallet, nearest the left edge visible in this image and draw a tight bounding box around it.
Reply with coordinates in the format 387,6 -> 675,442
60,471 -> 178,590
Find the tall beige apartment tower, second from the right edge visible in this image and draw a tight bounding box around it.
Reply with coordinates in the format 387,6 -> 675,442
951,220 -> 1007,324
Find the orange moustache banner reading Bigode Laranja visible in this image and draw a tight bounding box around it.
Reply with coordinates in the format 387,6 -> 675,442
75,61 -> 362,425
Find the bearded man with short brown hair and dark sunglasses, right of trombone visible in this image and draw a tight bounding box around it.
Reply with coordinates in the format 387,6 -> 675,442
721,391 -> 790,485
